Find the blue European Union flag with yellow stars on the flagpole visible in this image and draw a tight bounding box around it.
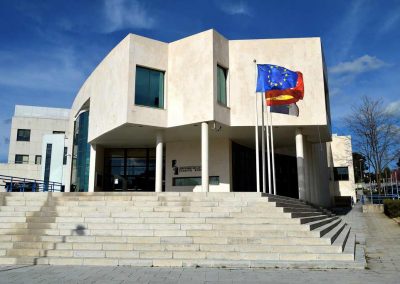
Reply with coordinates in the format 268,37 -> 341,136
256,64 -> 298,92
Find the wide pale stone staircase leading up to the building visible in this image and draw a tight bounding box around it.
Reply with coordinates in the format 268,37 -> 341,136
0,192 -> 364,268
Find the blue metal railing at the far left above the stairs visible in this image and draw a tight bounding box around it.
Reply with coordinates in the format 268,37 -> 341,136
0,175 -> 63,192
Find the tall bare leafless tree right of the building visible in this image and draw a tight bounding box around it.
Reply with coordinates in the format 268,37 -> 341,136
345,97 -> 400,191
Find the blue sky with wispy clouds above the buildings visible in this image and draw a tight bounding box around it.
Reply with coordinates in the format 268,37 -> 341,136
0,0 -> 400,162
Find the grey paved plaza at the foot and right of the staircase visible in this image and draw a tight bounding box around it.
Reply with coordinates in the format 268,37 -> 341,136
0,206 -> 400,284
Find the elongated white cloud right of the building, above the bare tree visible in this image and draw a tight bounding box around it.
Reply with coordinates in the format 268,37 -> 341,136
330,55 -> 387,75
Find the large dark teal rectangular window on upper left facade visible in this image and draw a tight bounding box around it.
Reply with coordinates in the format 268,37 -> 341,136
135,66 -> 164,108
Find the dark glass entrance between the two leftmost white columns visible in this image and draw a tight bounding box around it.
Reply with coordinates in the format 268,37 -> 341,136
103,148 -> 156,191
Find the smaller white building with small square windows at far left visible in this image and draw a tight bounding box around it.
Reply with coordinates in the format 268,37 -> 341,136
0,105 -> 70,187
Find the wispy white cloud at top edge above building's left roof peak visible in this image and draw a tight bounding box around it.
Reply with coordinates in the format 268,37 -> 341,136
103,0 -> 156,33
